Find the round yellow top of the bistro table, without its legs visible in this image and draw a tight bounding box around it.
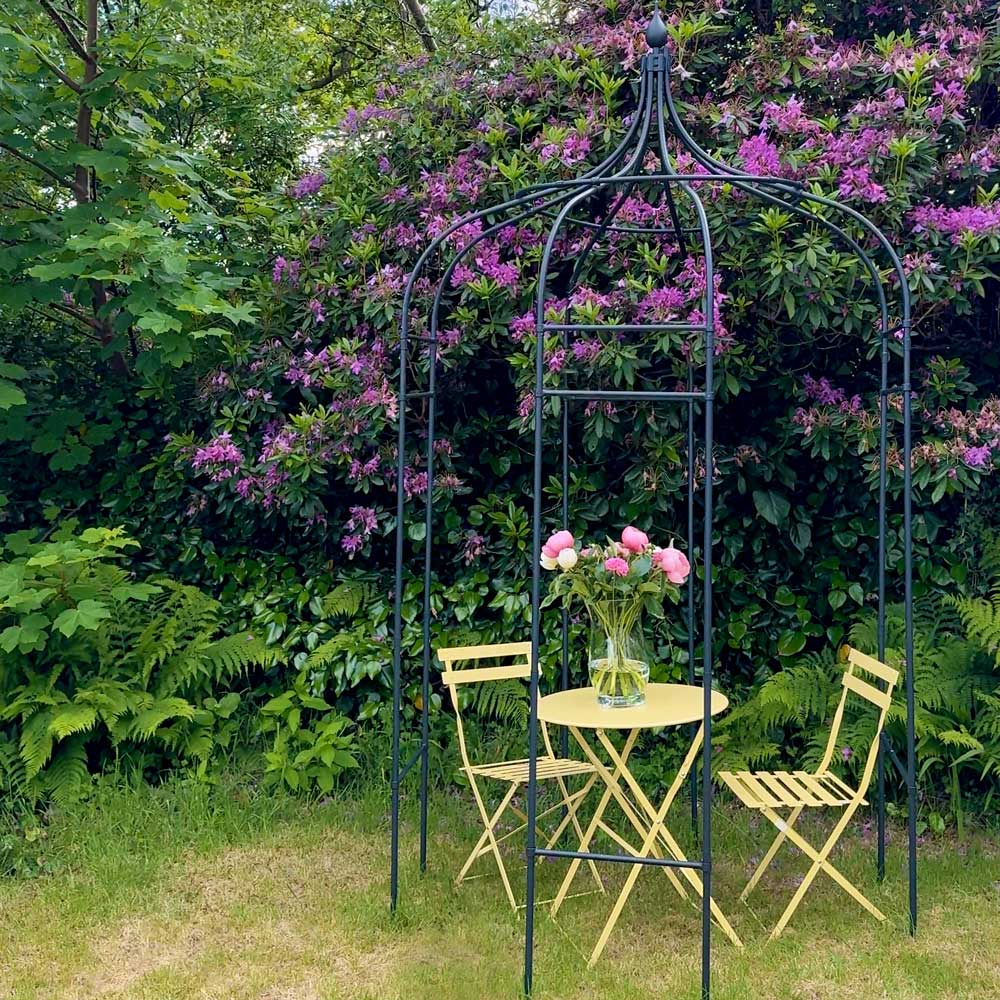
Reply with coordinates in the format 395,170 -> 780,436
538,684 -> 729,729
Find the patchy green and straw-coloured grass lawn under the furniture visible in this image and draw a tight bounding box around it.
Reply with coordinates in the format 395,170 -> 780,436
0,783 -> 1000,1000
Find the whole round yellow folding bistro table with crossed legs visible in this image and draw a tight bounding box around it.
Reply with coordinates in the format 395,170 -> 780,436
538,684 -> 743,965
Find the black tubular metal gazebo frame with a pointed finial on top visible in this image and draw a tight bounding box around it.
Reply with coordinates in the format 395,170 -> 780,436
390,10 -> 917,998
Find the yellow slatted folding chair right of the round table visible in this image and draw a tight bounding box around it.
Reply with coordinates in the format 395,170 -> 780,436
719,646 -> 899,940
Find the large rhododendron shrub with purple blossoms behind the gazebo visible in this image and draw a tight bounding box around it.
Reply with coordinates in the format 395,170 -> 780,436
160,0 -> 1000,704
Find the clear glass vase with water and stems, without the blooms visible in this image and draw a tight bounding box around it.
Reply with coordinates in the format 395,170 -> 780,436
587,609 -> 649,708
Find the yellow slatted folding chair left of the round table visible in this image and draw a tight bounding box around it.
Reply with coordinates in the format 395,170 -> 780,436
436,642 -> 604,910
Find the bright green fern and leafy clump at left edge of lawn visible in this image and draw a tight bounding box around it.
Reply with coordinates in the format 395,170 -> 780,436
0,522 -> 275,800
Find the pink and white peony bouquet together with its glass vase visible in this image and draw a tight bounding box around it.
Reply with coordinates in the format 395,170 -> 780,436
541,525 -> 691,708
